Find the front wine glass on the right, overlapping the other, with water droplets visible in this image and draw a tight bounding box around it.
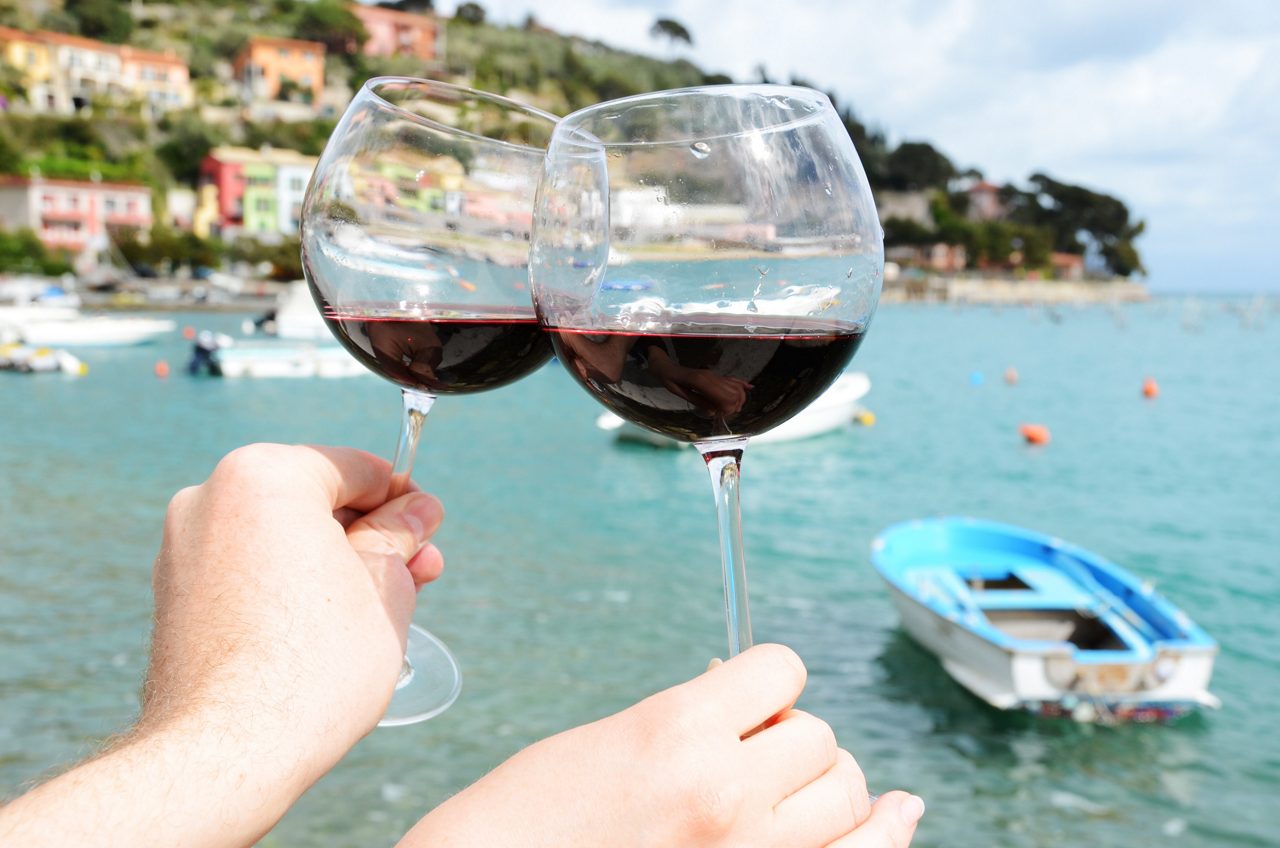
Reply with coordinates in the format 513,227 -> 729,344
530,85 -> 884,656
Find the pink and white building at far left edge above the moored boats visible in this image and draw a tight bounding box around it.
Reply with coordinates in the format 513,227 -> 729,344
0,174 -> 152,254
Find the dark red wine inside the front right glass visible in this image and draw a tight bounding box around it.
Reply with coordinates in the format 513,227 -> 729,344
548,315 -> 863,442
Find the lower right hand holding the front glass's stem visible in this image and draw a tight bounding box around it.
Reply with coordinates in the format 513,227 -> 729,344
401,646 -> 923,848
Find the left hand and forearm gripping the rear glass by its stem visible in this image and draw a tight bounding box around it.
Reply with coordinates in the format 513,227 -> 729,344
0,444 -> 443,848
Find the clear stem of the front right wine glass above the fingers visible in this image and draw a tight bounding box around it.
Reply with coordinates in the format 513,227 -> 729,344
698,438 -> 753,657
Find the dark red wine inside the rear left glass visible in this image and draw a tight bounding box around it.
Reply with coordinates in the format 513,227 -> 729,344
321,304 -> 552,395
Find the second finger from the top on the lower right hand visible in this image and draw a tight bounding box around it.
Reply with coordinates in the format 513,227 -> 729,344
742,710 -> 844,804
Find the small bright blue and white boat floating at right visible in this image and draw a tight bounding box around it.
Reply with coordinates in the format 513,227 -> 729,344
872,518 -> 1221,722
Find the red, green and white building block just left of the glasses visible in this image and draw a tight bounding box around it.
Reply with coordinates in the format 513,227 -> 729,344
192,147 -> 317,238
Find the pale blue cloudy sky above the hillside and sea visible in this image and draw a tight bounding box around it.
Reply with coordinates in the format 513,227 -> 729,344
435,0 -> 1280,293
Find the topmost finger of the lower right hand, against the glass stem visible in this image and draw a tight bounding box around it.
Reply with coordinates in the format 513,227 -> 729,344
676,644 -> 806,735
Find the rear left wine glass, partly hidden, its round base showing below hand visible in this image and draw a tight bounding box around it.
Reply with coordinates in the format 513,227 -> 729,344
301,77 -> 556,726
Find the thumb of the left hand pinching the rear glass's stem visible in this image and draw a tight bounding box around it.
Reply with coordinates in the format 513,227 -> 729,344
347,492 -> 444,616
